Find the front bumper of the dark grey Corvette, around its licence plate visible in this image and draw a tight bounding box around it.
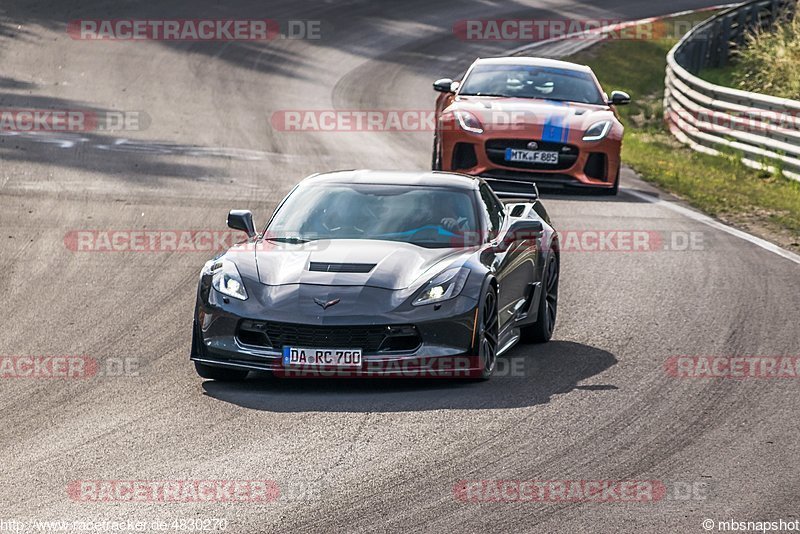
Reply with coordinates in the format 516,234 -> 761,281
191,285 -> 482,378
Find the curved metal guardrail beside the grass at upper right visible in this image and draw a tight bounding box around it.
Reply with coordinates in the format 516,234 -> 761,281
664,0 -> 800,180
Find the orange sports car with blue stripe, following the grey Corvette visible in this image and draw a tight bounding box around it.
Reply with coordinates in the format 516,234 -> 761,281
432,57 -> 630,195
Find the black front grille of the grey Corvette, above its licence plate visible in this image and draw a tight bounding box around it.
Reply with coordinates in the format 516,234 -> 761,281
236,319 -> 422,353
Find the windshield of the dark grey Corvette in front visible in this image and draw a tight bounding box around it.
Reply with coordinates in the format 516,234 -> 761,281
265,184 -> 478,248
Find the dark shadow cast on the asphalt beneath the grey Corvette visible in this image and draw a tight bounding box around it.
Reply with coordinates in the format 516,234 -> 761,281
203,341 -> 617,412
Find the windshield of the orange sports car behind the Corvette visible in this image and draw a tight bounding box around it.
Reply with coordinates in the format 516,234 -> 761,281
458,65 -> 605,104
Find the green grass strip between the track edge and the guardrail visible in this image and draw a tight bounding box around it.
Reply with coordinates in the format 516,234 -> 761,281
567,15 -> 800,249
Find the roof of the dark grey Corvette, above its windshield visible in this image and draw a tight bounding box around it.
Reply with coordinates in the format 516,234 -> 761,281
302,169 -> 479,189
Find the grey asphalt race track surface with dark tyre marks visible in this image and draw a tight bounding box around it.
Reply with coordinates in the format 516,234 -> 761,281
0,0 -> 800,533
